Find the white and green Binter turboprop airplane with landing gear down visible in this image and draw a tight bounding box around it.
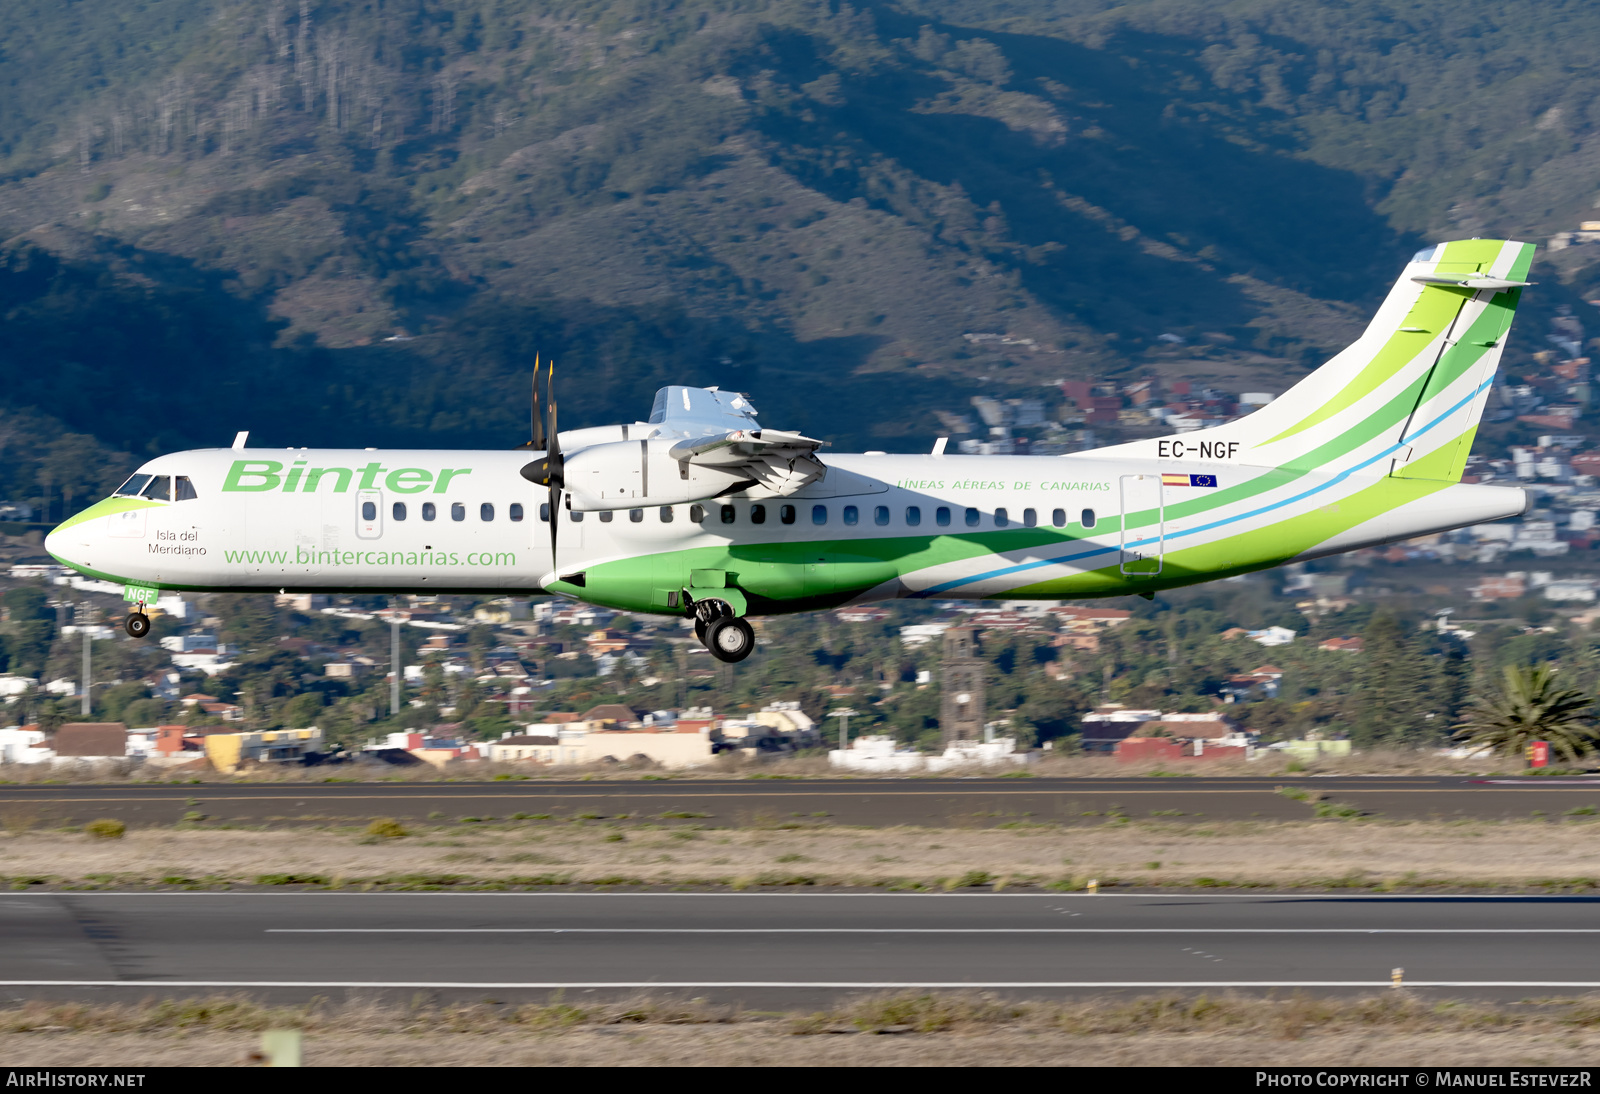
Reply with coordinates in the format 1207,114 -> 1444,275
46,240 -> 1534,661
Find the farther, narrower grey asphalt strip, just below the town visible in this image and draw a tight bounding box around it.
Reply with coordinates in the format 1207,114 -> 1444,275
0,776 -> 1600,827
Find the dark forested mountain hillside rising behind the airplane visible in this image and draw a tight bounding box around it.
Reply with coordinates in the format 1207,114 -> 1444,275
0,0 -> 1600,508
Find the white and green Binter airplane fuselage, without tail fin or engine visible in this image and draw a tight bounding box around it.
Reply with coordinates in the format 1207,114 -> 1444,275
48,435 -> 1525,614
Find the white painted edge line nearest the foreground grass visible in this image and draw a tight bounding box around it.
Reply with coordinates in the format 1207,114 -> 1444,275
9,979 -> 1600,990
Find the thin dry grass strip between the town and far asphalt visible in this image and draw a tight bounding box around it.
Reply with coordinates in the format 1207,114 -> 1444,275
0,749 -> 1548,785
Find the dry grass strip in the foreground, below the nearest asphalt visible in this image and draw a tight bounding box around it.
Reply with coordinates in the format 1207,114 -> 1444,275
9,992 -> 1600,1067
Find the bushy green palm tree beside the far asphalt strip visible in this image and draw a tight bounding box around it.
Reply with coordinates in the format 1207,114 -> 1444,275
1454,665 -> 1595,760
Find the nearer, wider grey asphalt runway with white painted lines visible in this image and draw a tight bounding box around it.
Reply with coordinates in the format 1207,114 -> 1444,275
0,892 -> 1600,1006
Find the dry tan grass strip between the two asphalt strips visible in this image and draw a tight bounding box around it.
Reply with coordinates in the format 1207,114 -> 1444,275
0,817 -> 1600,891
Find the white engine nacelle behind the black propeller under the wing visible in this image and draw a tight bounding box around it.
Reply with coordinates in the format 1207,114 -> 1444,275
563,440 -> 757,513
